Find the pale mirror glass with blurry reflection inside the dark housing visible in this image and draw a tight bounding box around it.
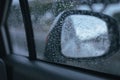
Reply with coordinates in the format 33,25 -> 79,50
61,15 -> 110,58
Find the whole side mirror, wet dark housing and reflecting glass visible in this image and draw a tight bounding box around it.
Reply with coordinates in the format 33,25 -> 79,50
44,10 -> 119,62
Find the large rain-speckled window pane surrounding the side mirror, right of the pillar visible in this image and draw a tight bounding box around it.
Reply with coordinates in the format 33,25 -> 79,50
29,0 -> 120,75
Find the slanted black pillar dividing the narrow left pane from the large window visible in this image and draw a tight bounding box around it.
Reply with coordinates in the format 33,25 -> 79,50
19,0 -> 36,60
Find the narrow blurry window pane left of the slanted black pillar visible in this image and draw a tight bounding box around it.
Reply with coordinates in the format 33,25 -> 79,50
7,0 -> 28,56
